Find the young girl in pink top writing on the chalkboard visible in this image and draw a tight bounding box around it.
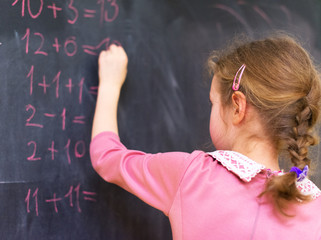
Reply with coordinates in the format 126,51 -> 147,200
91,36 -> 321,240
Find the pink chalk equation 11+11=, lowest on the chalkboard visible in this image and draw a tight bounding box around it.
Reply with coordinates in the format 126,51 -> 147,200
24,183 -> 97,216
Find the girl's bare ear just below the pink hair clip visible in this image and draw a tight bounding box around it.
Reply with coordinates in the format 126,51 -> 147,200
232,91 -> 246,125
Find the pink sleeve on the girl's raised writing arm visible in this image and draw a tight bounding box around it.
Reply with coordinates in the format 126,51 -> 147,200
90,132 -> 201,215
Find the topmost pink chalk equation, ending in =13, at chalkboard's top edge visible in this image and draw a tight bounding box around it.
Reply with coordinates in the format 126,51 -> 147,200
11,0 -> 119,25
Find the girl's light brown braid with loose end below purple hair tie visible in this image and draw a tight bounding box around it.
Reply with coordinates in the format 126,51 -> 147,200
260,97 -> 317,216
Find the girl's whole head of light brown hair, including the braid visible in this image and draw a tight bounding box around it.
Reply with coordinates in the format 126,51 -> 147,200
208,34 -> 321,215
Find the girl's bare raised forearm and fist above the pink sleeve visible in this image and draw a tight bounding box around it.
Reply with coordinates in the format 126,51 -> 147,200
91,45 -> 128,139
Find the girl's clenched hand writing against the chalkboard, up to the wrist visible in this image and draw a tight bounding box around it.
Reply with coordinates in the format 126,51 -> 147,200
98,44 -> 128,90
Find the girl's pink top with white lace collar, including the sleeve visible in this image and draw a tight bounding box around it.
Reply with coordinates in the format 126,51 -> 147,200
90,132 -> 321,240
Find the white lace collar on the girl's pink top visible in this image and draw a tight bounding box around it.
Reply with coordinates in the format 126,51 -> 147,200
209,150 -> 321,199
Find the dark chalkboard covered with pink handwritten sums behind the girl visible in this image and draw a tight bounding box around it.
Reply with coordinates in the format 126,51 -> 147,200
0,0 -> 321,240
